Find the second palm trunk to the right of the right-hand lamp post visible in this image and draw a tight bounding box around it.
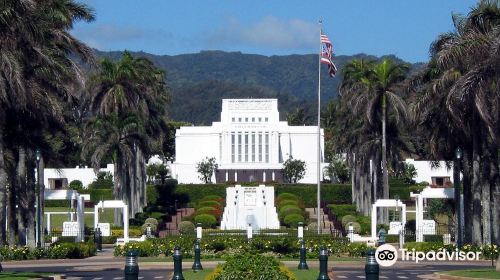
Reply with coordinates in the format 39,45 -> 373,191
472,122 -> 483,245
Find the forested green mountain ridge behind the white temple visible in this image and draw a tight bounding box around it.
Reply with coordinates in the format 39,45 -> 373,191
96,51 -> 419,124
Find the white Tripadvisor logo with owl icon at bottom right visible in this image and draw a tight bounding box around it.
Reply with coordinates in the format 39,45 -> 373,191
375,244 -> 481,267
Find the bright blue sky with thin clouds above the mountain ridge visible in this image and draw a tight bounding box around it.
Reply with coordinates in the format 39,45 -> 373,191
72,0 -> 477,62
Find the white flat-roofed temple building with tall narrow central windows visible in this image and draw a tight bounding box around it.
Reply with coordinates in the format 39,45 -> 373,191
170,99 -> 327,183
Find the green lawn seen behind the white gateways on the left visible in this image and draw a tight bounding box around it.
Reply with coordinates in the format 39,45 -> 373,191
44,207 -> 114,230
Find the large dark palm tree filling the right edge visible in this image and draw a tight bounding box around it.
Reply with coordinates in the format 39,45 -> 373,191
416,1 -> 500,244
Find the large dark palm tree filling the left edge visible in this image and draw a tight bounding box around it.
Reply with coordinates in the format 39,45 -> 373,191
0,0 -> 93,245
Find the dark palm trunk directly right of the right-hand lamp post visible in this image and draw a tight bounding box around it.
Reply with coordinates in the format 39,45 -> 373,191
462,149 -> 472,244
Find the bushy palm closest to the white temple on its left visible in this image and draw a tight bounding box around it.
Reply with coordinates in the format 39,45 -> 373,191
86,52 -> 169,218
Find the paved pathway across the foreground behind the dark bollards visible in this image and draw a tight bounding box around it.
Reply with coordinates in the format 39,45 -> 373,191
2,250 -> 491,280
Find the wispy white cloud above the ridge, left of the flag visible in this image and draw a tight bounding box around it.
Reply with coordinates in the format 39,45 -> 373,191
206,16 -> 318,49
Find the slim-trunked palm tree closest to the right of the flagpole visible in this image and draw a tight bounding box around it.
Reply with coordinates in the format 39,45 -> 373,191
340,59 -> 409,222
